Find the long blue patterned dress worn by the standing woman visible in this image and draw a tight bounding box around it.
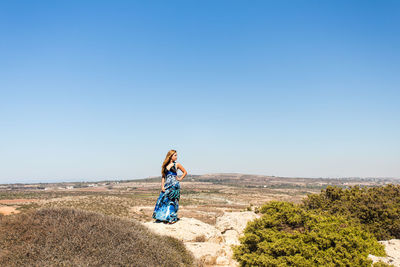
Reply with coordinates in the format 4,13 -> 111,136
153,162 -> 181,222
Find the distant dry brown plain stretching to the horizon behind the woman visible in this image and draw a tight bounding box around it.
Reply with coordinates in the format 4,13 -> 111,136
0,173 -> 400,223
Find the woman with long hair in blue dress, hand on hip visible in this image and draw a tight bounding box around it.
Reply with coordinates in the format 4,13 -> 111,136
153,149 -> 187,224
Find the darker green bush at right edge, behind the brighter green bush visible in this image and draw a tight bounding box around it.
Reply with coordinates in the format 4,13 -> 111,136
303,185 -> 400,240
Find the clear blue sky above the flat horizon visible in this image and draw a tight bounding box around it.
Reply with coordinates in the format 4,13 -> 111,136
0,0 -> 400,183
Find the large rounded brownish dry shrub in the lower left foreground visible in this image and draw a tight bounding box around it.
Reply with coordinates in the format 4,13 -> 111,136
0,208 -> 194,266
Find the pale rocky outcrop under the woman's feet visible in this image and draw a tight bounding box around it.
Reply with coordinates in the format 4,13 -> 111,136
143,211 -> 259,266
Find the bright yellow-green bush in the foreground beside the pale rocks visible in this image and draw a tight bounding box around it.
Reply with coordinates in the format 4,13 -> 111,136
233,201 -> 385,266
